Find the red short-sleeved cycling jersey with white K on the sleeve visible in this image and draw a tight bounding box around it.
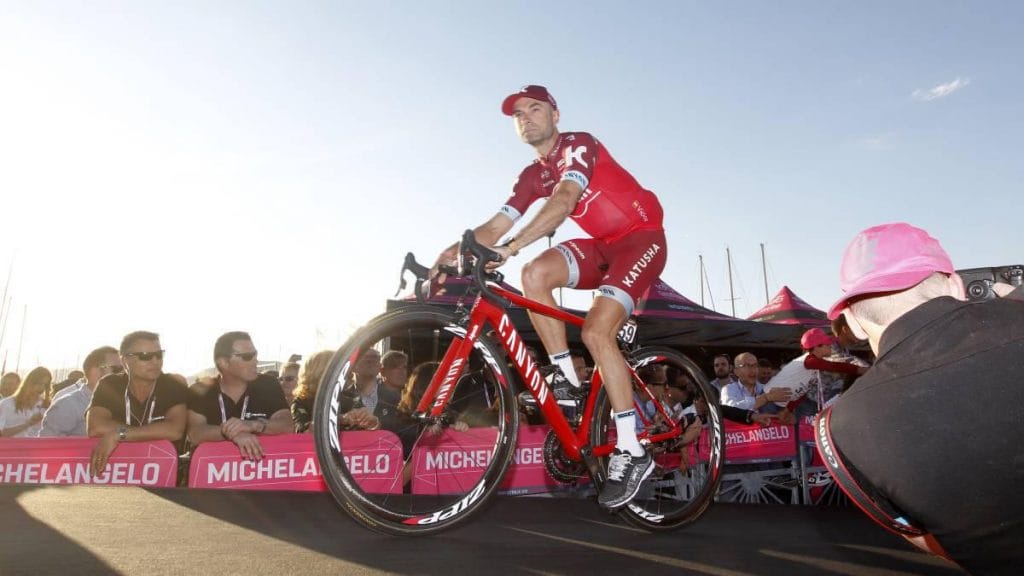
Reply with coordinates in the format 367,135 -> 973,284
502,132 -> 662,242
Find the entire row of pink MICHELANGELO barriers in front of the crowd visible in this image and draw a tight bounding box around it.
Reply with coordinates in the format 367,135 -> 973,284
0,418 -> 824,503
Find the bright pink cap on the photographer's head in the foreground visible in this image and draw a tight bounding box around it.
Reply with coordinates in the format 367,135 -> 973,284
828,222 -> 954,320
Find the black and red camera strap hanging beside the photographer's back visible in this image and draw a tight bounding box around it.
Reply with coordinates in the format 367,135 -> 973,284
814,406 -> 952,560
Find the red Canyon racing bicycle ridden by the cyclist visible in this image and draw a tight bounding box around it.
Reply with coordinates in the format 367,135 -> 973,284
313,231 -> 724,535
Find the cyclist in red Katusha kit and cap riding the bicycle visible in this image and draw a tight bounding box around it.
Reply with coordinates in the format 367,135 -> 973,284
431,85 -> 667,509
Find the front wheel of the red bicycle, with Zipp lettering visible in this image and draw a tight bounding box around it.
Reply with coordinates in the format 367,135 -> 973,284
313,306 -> 519,536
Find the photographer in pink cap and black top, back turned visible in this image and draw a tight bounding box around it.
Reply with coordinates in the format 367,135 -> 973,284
818,223 -> 1024,574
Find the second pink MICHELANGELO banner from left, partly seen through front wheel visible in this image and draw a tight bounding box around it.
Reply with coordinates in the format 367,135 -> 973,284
188,430 -> 401,493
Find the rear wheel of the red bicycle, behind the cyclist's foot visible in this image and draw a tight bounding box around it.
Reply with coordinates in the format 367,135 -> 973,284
591,347 -> 725,531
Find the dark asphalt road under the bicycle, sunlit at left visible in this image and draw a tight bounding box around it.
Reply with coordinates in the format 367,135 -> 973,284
0,485 -> 961,576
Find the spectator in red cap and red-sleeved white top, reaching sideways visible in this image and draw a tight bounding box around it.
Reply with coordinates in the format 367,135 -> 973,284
769,328 -> 867,419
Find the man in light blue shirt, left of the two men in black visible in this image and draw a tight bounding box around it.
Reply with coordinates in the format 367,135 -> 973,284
39,346 -> 124,437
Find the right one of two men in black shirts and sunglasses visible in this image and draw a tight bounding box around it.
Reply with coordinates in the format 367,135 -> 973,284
188,332 -> 292,460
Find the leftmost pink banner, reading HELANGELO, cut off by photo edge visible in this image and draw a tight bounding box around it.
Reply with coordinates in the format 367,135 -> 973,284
0,438 -> 178,487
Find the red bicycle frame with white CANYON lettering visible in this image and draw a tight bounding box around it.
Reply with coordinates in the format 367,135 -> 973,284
407,284 -> 682,461
